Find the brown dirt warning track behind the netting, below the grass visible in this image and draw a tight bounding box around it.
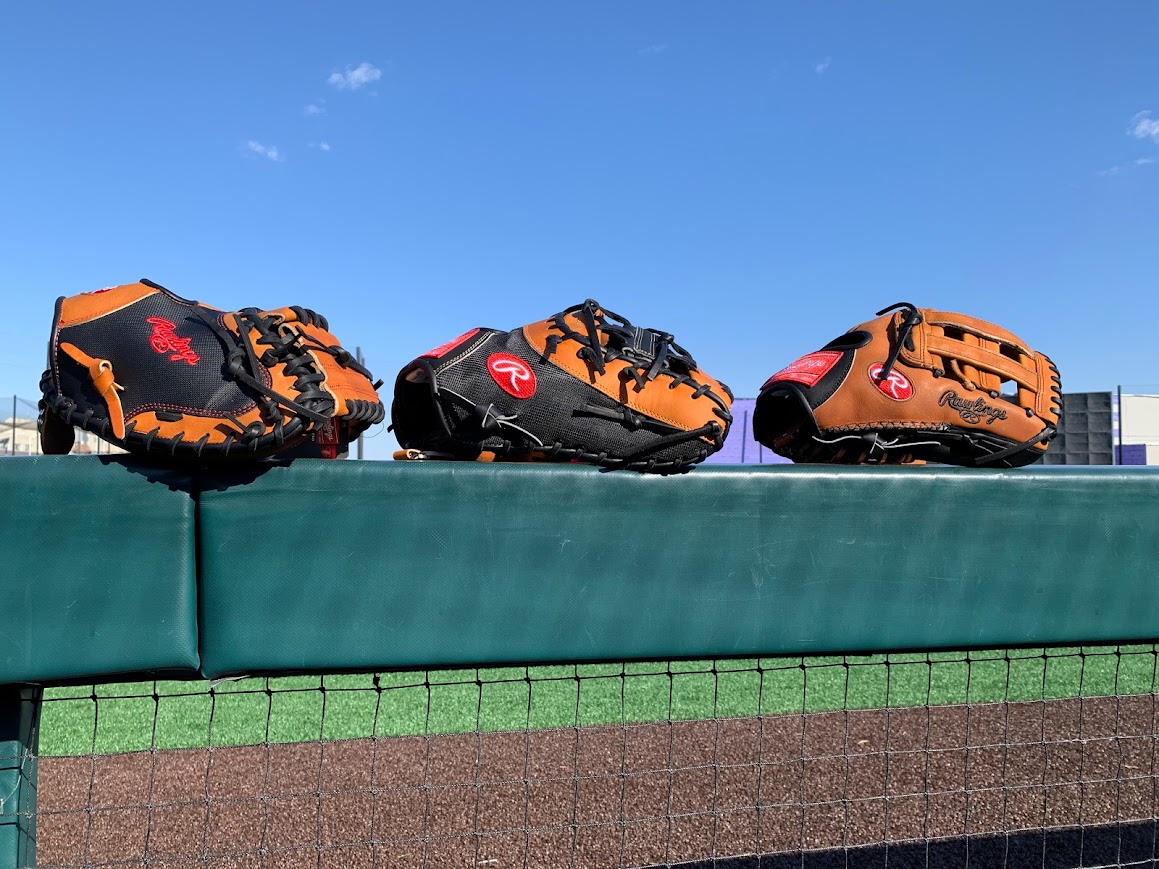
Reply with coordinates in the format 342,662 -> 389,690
37,694 -> 1157,869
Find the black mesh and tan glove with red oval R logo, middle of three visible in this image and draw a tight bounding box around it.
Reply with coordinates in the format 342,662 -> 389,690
391,299 -> 732,472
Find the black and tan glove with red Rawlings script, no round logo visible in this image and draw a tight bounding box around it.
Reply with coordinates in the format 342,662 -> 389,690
41,280 -> 386,460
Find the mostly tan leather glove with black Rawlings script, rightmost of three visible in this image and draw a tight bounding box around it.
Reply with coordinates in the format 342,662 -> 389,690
752,302 -> 1062,468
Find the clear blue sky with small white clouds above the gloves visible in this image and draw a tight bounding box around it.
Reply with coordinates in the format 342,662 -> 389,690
0,1 -> 1159,458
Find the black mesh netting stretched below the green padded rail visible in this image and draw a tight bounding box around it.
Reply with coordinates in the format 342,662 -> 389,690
20,645 -> 1159,869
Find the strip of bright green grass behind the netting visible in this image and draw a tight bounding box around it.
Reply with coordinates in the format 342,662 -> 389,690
41,644 -> 1157,755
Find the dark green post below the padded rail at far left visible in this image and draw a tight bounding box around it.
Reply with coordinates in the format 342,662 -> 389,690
0,685 -> 43,869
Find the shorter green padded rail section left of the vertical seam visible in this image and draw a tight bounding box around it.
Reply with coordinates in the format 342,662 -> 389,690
0,455 -> 198,685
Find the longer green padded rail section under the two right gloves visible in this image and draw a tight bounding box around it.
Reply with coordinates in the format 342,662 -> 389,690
201,460 -> 1159,677
